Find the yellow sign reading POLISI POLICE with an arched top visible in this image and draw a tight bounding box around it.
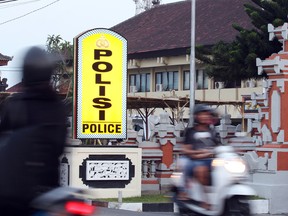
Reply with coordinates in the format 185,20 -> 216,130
74,29 -> 127,138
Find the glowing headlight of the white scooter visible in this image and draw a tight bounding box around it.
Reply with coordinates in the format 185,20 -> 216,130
212,158 -> 246,173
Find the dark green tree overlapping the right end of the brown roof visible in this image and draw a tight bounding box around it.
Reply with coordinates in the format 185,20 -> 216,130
196,0 -> 288,81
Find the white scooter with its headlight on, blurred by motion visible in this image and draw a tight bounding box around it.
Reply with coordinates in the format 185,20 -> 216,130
171,146 -> 256,216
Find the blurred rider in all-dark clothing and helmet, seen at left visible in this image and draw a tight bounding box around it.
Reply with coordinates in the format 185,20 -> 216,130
0,47 -> 66,216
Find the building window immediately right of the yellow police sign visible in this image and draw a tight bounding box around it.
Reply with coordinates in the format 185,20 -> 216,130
129,73 -> 150,92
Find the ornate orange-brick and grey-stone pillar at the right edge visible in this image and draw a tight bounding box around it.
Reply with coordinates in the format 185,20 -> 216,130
244,23 -> 288,214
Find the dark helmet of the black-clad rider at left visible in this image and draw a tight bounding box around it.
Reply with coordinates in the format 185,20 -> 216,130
23,47 -> 53,86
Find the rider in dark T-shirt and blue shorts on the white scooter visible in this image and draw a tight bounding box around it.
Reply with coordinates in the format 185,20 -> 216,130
182,104 -> 219,208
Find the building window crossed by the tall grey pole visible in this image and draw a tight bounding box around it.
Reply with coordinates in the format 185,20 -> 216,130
183,70 -> 209,90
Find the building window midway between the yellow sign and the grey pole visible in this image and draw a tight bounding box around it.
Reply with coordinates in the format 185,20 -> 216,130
155,71 -> 178,91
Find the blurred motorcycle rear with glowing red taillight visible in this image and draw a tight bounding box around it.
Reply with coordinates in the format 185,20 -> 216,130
31,187 -> 96,216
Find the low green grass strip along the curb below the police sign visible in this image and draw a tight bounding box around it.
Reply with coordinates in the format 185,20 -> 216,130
99,194 -> 171,203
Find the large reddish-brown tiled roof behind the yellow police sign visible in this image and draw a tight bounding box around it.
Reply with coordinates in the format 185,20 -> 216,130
111,0 -> 252,56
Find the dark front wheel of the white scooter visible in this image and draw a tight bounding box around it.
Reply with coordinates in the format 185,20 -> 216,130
222,196 -> 251,216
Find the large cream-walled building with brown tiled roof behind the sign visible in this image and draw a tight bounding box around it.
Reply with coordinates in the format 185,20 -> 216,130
112,0 -> 262,125
